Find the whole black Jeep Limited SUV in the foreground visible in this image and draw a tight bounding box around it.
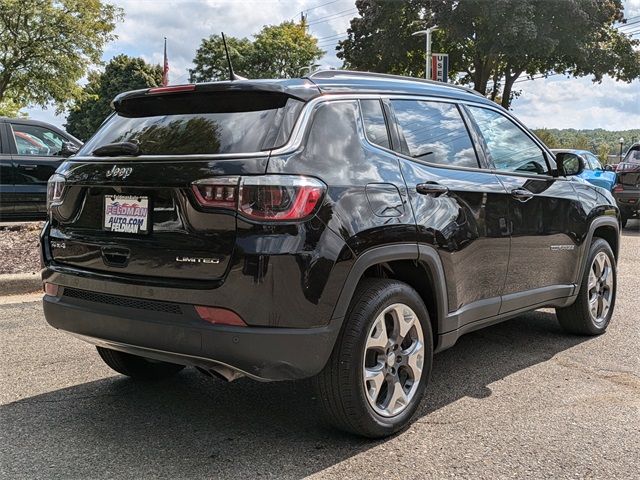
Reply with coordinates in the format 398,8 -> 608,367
42,71 -> 620,437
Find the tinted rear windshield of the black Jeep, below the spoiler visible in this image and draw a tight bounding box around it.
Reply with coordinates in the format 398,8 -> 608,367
78,93 -> 303,156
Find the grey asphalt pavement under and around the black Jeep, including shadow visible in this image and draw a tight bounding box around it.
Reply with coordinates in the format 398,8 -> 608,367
0,221 -> 640,480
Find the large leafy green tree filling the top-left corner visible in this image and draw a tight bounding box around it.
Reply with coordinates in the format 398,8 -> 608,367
0,0 -> 121,111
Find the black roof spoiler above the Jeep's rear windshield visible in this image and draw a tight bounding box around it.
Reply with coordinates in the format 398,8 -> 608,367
111,79 -> 320,117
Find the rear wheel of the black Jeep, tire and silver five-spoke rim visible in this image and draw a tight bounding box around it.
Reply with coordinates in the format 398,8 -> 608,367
314,279 -> 433,438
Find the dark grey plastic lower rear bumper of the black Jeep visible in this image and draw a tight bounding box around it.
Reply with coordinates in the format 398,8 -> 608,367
43,291 -> 341,381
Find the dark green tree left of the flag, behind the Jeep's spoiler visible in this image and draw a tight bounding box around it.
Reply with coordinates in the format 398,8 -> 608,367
65,55 -> 162,140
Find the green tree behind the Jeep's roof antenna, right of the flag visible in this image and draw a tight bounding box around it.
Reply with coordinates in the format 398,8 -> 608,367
189,22 -> 324,82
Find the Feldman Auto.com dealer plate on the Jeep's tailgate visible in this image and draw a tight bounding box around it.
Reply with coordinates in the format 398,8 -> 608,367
102,194 -> 150,235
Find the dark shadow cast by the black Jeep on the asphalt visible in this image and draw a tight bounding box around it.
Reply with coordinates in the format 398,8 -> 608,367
0,311 -> 585,478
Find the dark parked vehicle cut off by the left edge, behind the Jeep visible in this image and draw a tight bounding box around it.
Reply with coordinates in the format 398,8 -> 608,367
0,117 -> 82,221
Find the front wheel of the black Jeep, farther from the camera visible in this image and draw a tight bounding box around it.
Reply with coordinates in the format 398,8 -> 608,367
556,238 -> 617,335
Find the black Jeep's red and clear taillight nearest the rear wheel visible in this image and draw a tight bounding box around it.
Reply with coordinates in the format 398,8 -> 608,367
192,175 -> 326,222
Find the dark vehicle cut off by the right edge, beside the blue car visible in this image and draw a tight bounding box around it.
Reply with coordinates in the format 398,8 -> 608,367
613,143 -> 640,226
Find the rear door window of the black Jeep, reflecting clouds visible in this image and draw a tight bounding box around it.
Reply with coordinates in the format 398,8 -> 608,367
391,100 -> 479,168
